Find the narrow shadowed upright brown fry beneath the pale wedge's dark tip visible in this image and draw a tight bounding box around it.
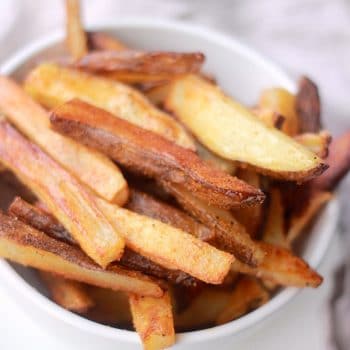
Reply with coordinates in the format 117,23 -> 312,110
262,188 -> 290,249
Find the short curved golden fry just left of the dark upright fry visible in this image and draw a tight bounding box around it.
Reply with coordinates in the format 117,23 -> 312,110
259,88 -> 300,136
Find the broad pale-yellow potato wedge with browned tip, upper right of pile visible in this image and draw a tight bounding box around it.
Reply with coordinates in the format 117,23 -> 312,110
166,75 -> 327,182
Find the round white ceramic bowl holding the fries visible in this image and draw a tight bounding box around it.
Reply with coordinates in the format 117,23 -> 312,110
0,19 -> 339,350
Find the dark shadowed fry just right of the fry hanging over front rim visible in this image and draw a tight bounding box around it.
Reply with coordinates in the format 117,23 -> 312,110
174,287 -> 230,331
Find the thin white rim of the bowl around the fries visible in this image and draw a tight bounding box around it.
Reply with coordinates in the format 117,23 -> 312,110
0,17 -> 339,345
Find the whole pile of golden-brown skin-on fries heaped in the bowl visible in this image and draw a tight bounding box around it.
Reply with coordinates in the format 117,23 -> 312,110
0,0 -> 350,350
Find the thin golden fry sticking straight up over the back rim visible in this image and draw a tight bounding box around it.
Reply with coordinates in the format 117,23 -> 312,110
66,0 -> 88,59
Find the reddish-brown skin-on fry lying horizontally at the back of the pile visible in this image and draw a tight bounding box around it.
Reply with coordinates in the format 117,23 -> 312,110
74,50 -> 205,75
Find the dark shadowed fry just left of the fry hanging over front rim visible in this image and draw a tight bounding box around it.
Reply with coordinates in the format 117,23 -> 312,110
85,285 -> 132,326
